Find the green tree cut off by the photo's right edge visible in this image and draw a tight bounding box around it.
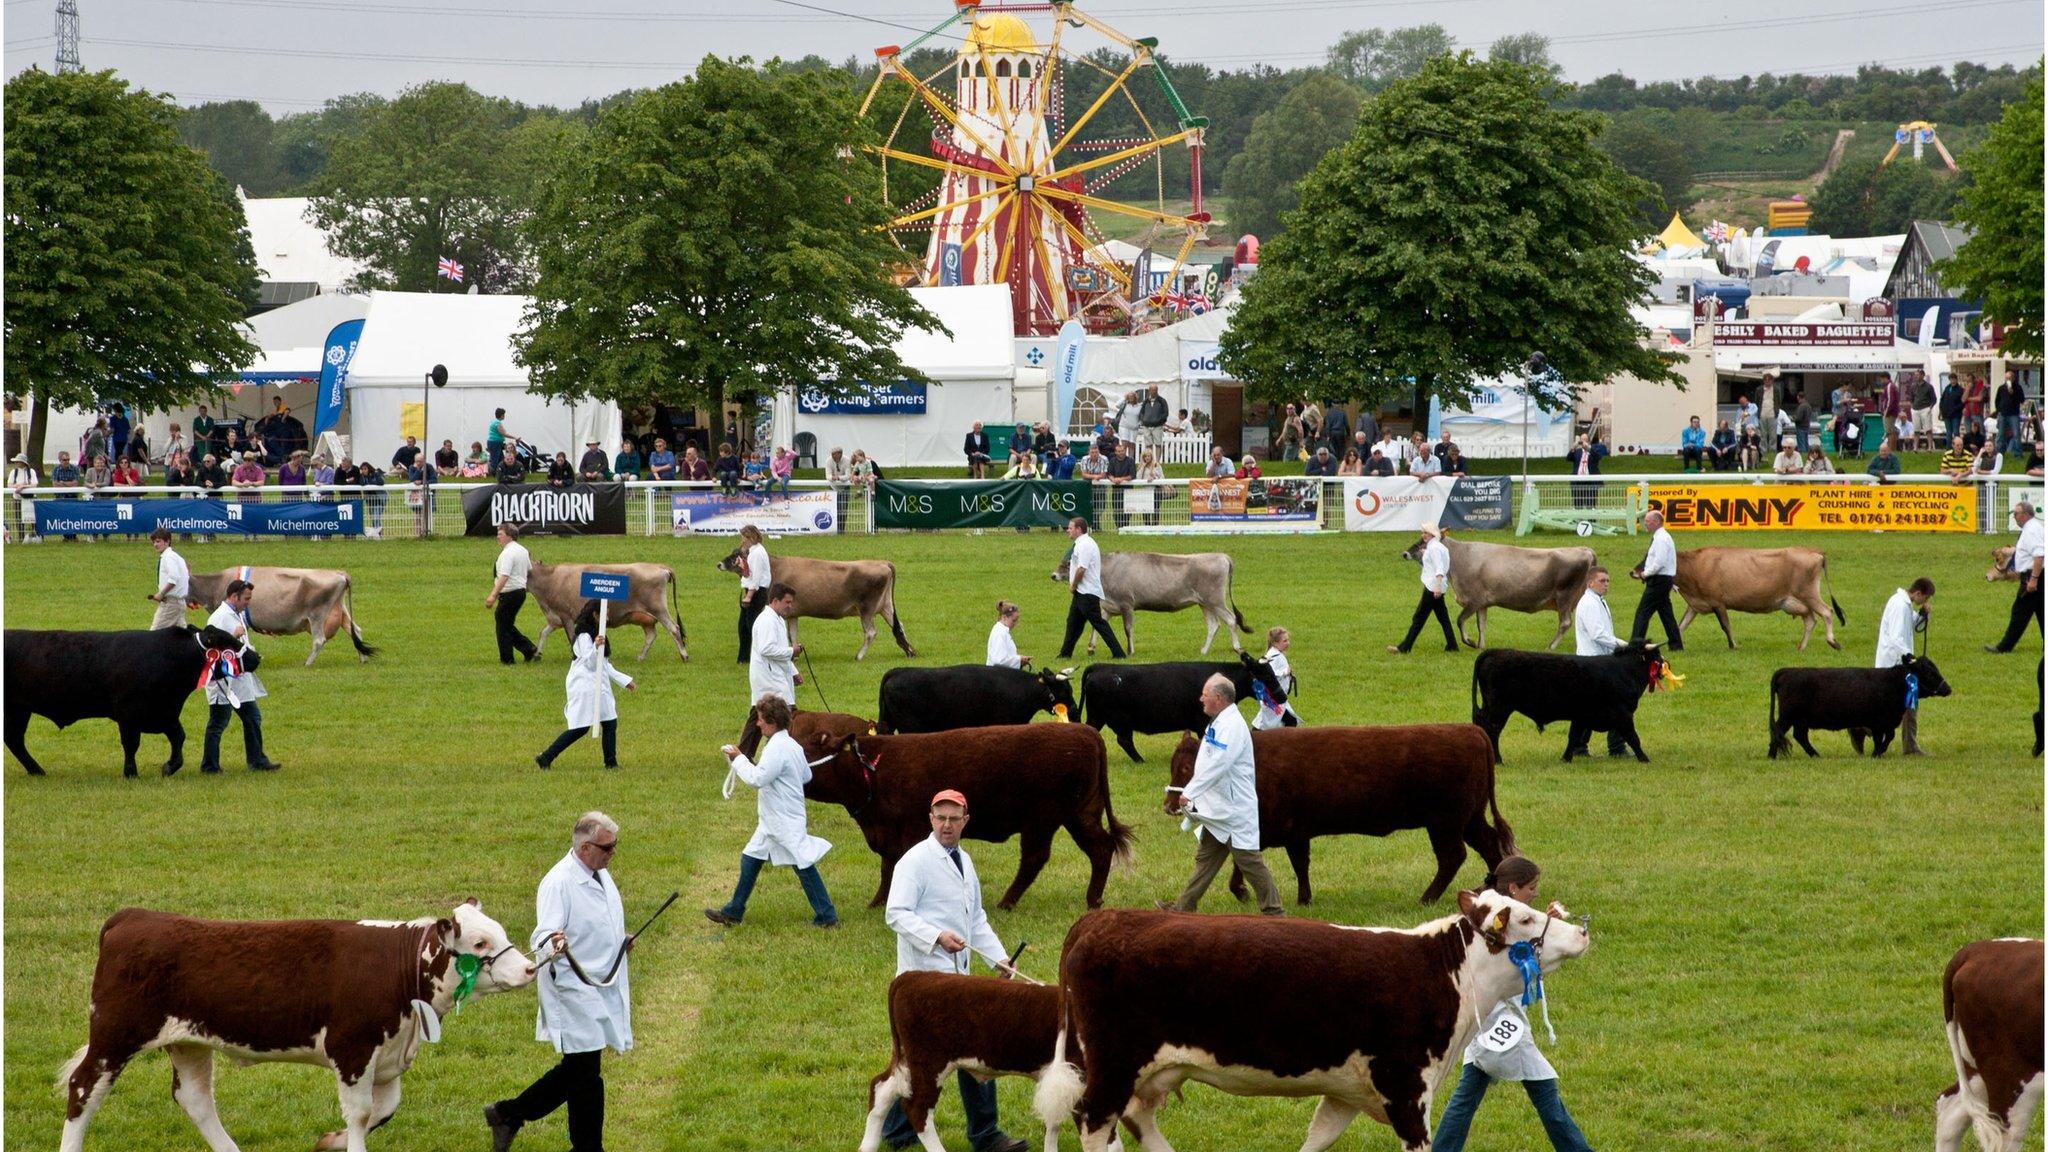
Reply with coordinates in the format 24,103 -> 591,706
1937,70 -> 2042,359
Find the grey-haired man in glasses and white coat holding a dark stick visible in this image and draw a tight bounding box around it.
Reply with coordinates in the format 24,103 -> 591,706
483,812 -> 633,1152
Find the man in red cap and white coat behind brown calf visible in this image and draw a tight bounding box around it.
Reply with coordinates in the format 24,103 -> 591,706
883,787 -> 1028,1152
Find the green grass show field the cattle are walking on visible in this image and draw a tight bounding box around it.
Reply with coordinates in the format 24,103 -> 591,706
4,533 -> 2042,1152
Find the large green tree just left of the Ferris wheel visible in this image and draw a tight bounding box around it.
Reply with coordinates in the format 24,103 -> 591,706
518,57 -> 942,448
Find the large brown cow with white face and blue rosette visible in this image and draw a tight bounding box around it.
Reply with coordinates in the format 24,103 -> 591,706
1032,892 -> 1591,1152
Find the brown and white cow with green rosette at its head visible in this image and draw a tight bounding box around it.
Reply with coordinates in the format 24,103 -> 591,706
57,900 -> 537,1152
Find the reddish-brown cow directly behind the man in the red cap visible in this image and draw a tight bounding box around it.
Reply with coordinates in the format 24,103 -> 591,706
803,724 -> 1130,910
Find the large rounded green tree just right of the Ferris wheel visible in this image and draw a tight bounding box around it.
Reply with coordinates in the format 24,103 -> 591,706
1223,53 -> 1673,412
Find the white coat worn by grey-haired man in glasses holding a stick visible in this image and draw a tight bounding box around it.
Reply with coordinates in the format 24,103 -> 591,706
528,853 -> 633,1054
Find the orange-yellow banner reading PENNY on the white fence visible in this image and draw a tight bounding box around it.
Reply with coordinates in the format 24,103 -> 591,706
1651,475 -> 1976,533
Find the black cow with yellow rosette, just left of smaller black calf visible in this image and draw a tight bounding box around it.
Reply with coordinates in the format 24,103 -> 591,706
1473,640 -> 1665,765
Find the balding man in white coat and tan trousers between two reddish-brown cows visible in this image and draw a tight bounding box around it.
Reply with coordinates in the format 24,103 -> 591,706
1159,674 -> 1282,916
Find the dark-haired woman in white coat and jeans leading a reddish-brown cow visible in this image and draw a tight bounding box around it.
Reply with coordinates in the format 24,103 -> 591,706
705,695 -> 840,929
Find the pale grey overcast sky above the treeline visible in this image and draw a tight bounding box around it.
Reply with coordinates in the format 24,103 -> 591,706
4,0 -> 2044,115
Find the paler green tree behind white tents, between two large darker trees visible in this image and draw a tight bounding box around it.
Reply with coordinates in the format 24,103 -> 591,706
307,82 -> 530,293
